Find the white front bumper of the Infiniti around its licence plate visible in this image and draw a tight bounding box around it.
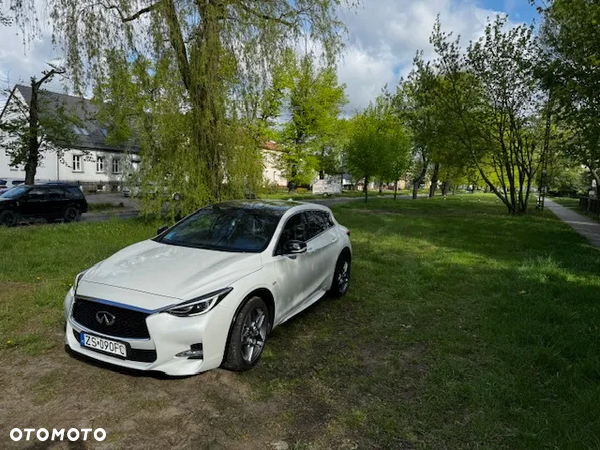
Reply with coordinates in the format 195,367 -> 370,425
65,290 -> 233,376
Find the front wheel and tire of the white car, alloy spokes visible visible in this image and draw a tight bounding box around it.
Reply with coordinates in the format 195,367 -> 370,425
222,296 -> 271,372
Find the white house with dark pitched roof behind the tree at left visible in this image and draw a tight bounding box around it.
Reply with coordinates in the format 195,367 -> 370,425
0,85 -> 140,191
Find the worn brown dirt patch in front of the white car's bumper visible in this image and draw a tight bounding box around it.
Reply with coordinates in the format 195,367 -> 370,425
0,351 -> 290,449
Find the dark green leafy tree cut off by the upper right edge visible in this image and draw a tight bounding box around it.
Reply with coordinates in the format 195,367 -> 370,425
539,0 -> 600,198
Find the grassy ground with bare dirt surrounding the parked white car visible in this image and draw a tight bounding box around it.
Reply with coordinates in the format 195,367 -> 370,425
0,195 -> 600,449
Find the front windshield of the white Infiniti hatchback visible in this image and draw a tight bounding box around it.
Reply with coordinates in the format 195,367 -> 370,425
158,205 -> 283,253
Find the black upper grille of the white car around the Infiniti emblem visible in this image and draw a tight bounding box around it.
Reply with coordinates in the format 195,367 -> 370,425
73,298 -> 150,339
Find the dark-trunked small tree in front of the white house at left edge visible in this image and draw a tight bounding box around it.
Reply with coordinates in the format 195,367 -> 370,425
0,67 -> 80,184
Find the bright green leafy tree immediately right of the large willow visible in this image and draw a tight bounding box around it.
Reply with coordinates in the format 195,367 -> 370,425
282,53 -> 347,189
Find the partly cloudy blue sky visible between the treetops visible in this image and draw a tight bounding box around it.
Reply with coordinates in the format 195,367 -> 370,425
0,0 -> 537,115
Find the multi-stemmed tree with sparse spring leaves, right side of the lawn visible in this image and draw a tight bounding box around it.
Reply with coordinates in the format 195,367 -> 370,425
431,16 -> 545,214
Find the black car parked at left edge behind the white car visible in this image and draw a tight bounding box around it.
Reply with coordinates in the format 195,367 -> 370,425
0,183 -> 87,227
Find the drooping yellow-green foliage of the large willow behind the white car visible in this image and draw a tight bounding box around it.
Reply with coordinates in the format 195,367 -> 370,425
51,0 -> 354,210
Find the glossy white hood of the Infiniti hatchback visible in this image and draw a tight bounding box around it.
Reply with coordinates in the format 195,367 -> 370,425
78,240 -> 262,304
